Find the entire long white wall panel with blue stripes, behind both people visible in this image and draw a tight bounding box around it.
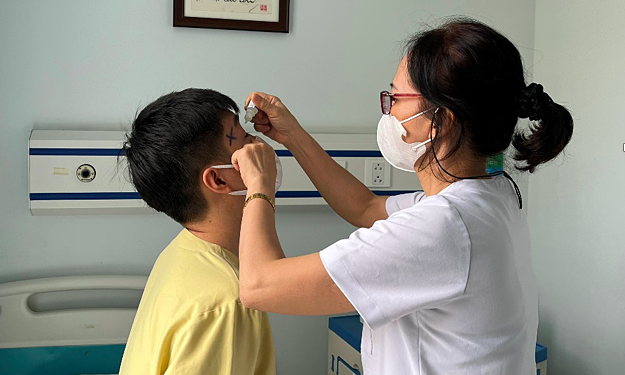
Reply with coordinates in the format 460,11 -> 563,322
29,130 -> 421,215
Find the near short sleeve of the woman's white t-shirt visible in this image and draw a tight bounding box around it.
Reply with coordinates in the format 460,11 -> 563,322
320,196 -> 471,329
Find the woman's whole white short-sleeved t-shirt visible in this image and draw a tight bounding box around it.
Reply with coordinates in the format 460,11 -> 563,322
321,176 -> 538,375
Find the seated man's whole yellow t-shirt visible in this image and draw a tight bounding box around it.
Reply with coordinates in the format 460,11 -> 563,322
120,229 -> 276,375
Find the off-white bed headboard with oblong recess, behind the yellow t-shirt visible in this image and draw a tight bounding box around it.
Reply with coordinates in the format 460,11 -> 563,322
0,276 -> 147,348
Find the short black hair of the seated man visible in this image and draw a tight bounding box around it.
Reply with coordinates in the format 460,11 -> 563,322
124,88 -> 239,224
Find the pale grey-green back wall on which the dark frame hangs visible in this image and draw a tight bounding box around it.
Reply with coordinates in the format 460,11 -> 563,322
0,0 -> 534,374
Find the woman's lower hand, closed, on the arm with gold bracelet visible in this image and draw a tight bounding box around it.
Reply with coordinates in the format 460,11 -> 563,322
232,139 -> 277,194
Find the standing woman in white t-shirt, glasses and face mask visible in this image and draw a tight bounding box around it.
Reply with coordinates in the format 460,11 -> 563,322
232,19 -> 573,375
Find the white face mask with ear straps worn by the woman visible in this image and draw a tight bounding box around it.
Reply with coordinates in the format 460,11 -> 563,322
377,108 -> 438,172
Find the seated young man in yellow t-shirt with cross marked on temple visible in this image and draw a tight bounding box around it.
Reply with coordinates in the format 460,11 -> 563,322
120,89 -> 275,375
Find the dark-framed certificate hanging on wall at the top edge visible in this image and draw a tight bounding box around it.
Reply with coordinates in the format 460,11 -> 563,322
174,0 -> 290,33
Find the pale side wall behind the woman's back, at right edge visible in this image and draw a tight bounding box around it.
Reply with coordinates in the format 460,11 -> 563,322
529,0 -> 625,375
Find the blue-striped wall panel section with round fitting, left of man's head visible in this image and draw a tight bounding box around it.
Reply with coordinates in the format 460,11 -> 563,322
29,130 -> 141,215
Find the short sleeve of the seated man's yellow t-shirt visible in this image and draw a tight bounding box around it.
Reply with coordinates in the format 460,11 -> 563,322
165,302 -> 276,375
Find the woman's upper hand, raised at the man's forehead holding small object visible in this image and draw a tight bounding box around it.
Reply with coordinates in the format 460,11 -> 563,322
245,92 -> 304,148
